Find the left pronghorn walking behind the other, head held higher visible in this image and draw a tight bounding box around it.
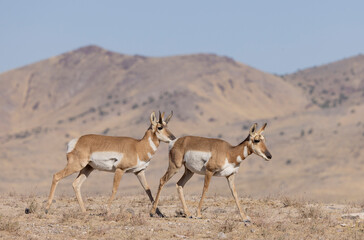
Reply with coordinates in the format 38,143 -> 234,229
46,112 -> 175,216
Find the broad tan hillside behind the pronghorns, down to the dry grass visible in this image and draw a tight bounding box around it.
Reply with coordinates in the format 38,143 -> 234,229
0,46 -> 364,201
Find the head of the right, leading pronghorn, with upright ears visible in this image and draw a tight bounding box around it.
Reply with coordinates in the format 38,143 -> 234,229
249,123 -> 272,161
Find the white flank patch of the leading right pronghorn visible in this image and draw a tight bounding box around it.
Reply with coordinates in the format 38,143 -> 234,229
183,151 -> 211,174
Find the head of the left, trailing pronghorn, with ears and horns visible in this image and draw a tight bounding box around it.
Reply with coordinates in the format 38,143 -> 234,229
150,111 -> 176,143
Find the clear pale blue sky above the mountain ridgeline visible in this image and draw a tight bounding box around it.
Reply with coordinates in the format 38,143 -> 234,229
0,0 -> 364,74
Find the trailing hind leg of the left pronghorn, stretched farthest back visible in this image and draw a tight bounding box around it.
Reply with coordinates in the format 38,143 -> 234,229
45,160 -> 83,213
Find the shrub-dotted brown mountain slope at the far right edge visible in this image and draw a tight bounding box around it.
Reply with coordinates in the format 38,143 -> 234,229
284,55 -> 364,108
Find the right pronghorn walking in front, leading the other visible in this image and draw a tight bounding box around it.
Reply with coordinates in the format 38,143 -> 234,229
150,123 -> 272,222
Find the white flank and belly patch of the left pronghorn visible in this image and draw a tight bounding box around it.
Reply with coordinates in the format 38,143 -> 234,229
89,152 -> 123,172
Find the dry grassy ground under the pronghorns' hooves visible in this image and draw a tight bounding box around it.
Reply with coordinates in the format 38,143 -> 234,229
0,194 -> 364,240
